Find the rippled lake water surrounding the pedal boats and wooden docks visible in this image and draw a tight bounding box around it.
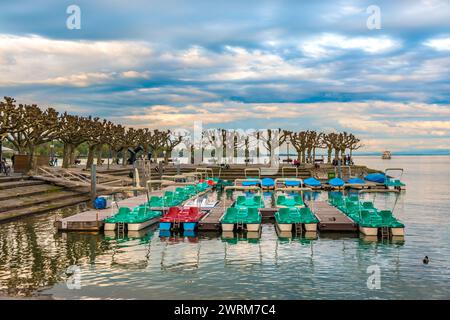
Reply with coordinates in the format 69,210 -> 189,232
0,156 -> 450,299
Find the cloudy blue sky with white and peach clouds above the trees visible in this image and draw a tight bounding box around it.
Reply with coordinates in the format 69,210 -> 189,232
0,0 -> 450,151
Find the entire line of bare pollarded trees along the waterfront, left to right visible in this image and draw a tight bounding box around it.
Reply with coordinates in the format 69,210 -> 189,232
0,97 -> 361,168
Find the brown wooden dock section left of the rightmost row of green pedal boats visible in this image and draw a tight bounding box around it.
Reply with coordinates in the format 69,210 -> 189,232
308,201 -> 358,231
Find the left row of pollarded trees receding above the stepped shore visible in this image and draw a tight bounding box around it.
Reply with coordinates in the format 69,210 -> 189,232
0,97 -> 182,168
